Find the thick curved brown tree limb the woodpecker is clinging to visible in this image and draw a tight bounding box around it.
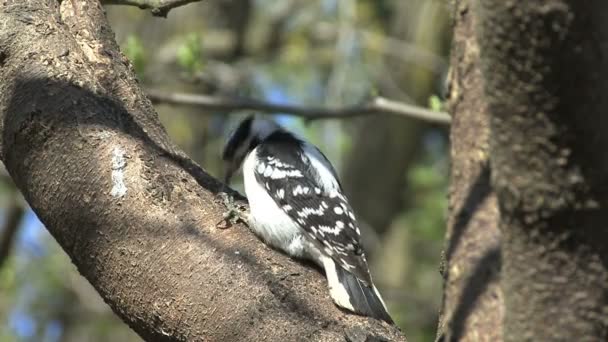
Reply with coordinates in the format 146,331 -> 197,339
0,0 -> 404,341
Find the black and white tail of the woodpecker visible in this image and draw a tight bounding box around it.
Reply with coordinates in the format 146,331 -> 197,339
324,258 -> 394,324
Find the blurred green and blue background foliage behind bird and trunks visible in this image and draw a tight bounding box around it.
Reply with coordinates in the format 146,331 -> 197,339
0,0 -> 451,342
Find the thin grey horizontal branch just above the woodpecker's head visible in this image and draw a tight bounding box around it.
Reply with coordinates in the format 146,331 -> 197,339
148,90 -> 451,125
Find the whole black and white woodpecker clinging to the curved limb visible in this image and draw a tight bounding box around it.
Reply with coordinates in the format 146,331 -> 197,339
222,117 -> 393,323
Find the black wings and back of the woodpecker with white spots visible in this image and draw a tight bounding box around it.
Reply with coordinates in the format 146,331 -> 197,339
255,132 -> 371,284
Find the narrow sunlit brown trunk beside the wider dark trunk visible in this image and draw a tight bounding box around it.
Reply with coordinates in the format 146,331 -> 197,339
437,0 -> 504,341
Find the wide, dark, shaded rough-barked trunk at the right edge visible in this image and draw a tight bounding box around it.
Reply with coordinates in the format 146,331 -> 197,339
475,0 -> 608,341
